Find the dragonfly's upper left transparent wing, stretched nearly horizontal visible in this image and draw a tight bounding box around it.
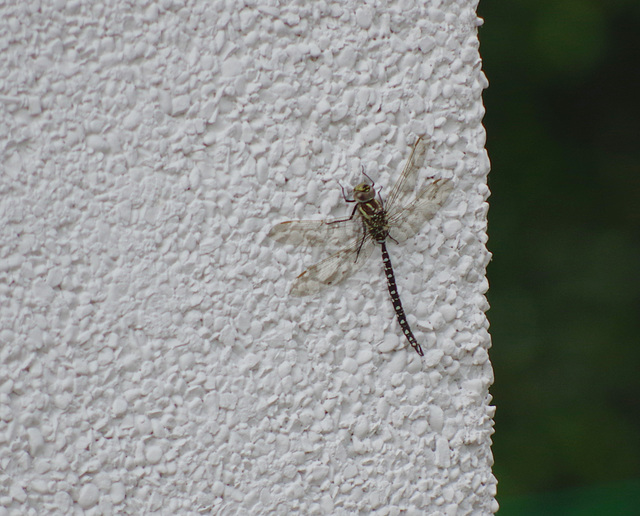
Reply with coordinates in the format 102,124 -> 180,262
269,217 -> 363,247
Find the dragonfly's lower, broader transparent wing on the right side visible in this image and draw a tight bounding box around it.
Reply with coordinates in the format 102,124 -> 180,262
389,179 -> 453,242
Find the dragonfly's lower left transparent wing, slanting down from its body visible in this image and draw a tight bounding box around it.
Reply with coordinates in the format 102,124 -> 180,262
291,236 -> 375,296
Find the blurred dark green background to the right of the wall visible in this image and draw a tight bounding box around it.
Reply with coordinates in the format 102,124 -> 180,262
478,0 -> 640,510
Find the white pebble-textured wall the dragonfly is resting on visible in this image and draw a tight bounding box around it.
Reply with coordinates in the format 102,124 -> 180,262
0,0 -> 497,515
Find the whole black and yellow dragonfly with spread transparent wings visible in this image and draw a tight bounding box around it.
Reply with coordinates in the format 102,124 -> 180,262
269,138 -> 453,356
